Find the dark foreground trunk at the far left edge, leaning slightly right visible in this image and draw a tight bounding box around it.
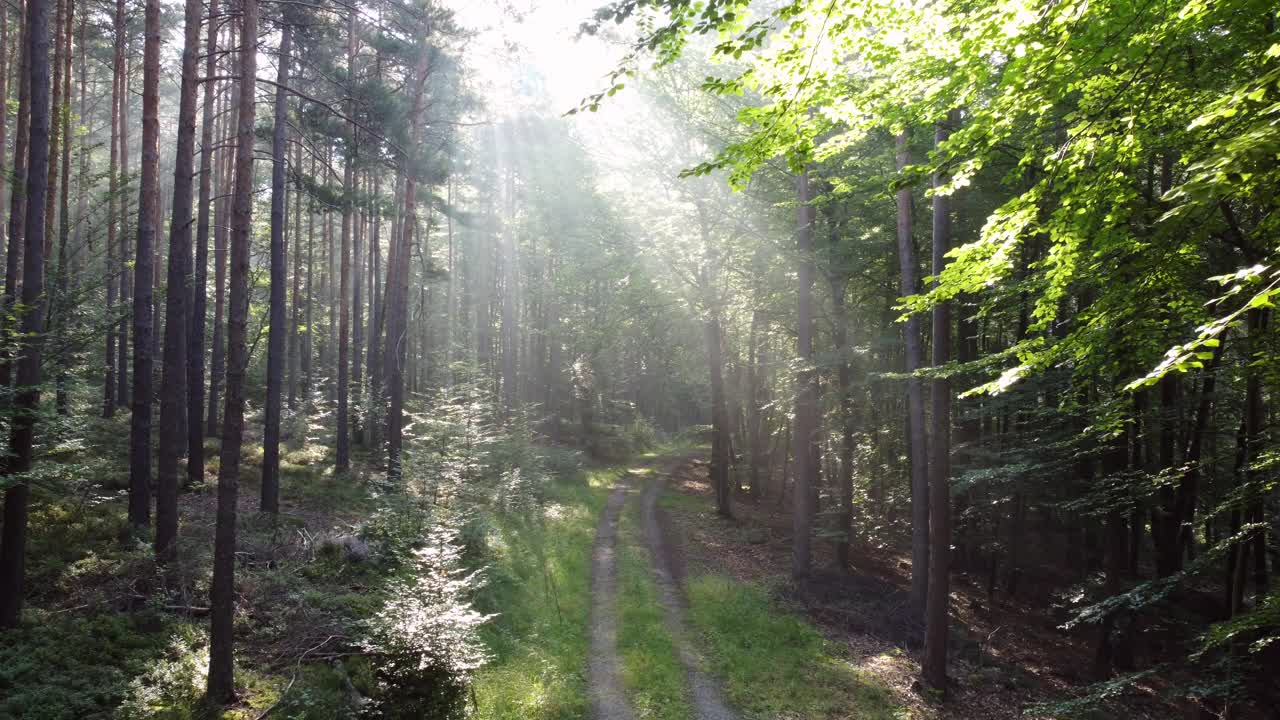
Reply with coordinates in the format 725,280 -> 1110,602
0,0 -> 50,628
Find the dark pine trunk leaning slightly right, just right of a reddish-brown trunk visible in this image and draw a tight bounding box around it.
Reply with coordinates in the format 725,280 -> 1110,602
156,0 -> 204,560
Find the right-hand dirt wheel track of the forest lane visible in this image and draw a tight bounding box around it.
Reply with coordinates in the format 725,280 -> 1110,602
643,459 -> 739,720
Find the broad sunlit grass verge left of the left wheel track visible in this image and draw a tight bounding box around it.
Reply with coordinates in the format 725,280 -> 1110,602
475,461 -> 617,720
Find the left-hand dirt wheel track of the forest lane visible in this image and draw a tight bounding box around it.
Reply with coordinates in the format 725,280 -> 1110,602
588,473 -> 635,720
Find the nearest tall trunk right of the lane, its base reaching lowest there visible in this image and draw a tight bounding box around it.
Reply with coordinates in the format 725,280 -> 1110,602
923,110 -> 960,694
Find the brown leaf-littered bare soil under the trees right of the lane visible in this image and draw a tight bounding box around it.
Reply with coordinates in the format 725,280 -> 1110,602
667,460 -> 1184,720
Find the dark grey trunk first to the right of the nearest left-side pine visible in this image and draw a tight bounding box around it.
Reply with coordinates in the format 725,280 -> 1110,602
259,20 -> 293,504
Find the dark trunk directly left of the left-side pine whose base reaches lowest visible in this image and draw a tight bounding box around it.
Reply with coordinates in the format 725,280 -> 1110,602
187,0 -> 218,484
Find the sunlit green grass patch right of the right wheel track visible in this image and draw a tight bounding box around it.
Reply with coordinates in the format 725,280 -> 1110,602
689,575 -> 908,720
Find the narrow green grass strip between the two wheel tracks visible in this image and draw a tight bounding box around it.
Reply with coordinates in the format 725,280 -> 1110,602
617,499 -> 692,720
